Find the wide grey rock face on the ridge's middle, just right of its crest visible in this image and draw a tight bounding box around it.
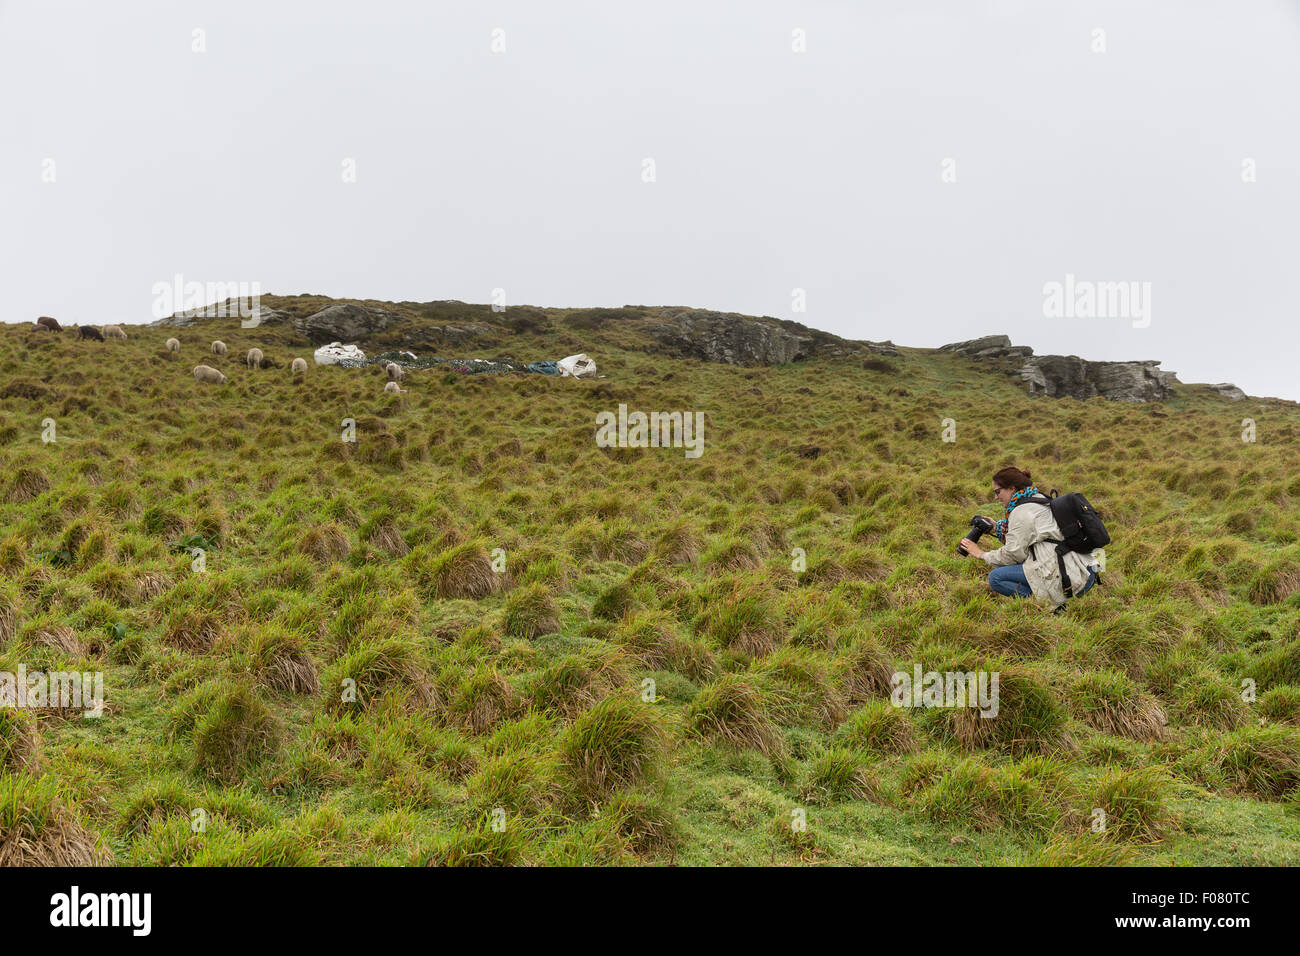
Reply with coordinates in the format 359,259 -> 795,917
646,310 -> 814,365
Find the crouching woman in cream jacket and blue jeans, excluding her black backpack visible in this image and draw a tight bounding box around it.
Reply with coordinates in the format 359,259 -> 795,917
962,467 -> 1097,611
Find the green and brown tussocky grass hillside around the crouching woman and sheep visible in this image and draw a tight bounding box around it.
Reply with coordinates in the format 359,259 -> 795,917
0,297 -> 1300,865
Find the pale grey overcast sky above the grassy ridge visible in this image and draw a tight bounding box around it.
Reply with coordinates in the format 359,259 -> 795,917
0,0 -> 1300,399
